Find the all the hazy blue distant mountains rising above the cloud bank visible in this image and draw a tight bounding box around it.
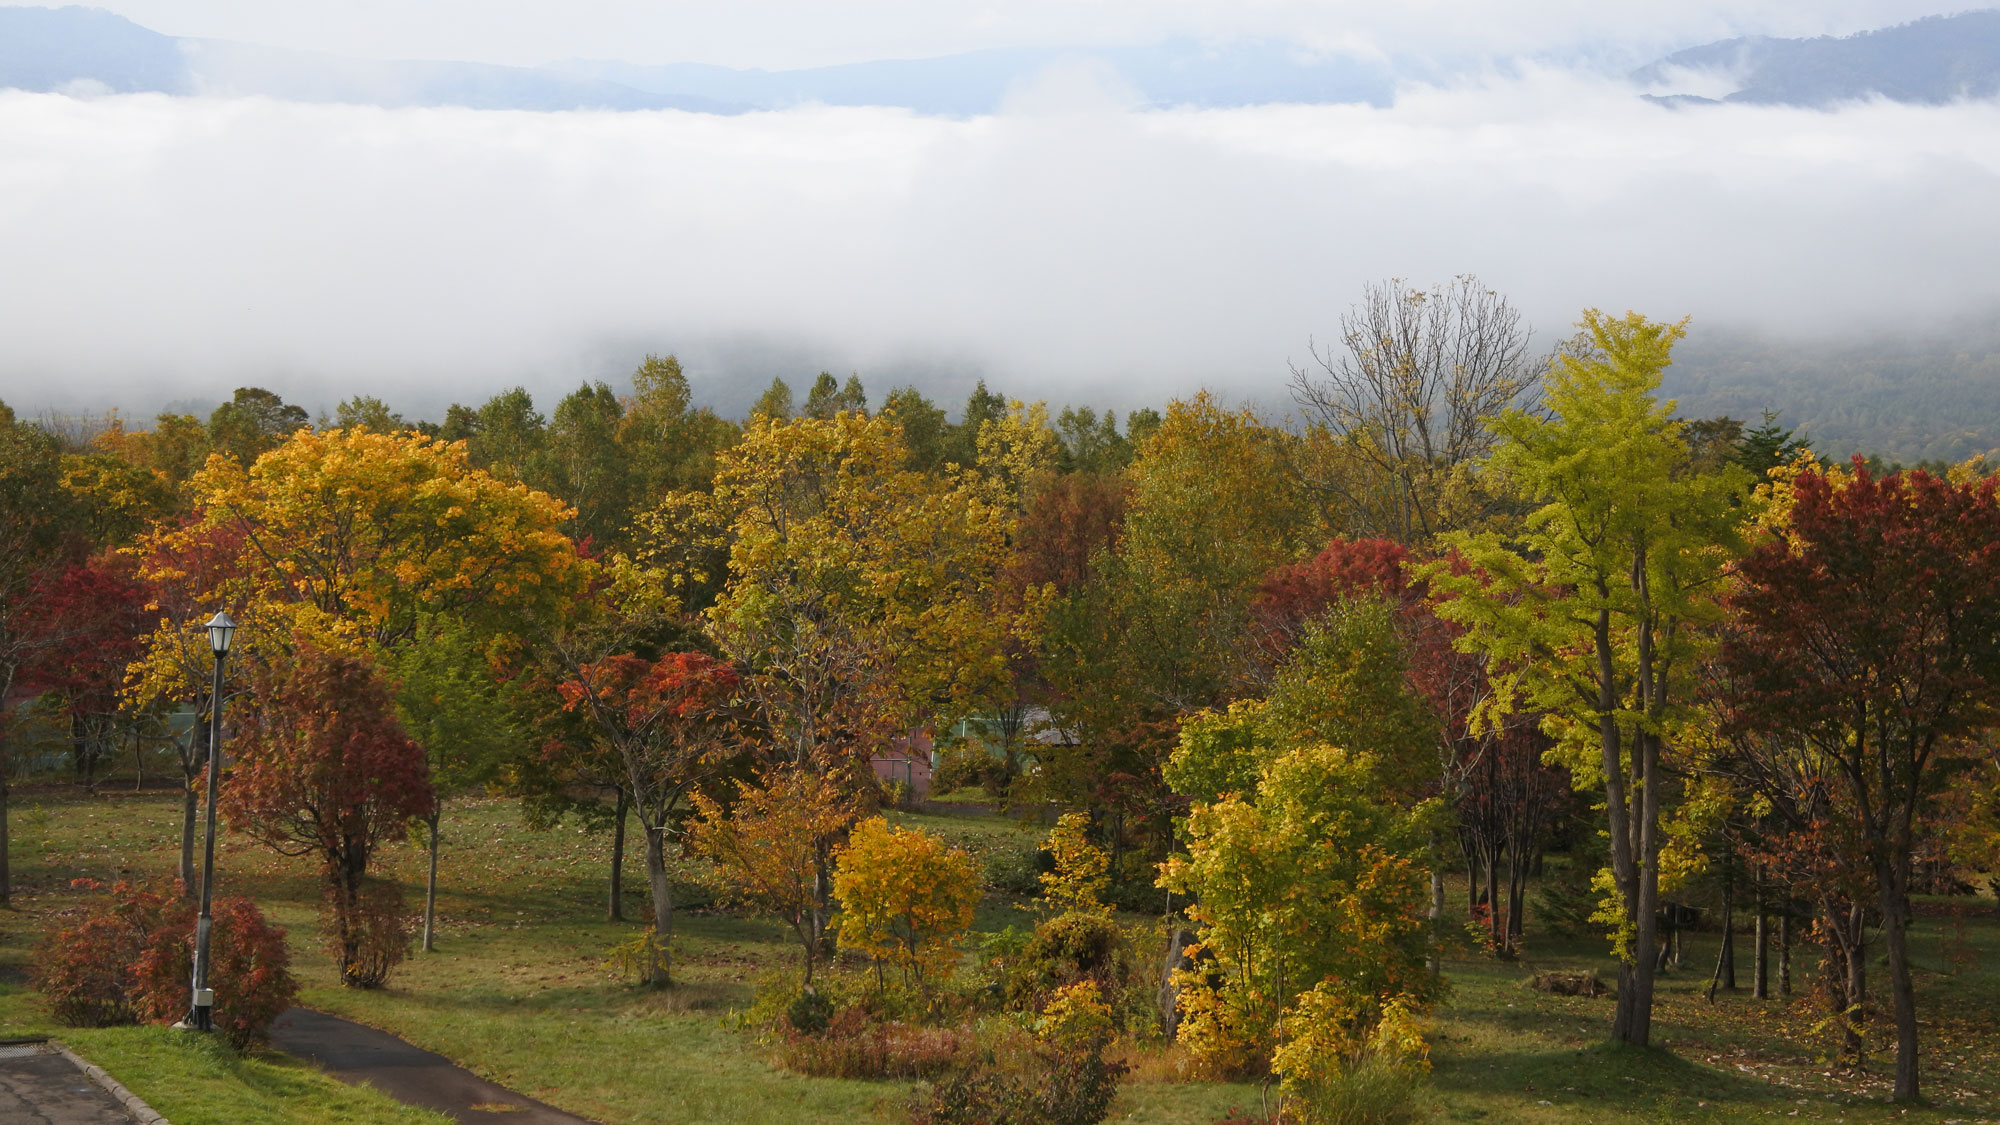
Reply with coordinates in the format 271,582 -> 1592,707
0,6 -> 2000,116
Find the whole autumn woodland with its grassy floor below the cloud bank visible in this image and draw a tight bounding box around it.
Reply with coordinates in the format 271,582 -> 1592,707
0,278 -> 2000,1125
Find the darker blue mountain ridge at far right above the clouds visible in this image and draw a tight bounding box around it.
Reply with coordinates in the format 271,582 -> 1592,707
1632,10 -> 2000,108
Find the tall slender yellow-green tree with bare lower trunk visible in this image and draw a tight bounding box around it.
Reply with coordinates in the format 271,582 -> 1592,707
1422,310 -> 1746,1045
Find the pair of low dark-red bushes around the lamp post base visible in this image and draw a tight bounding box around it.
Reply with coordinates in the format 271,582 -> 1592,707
32,883 -> 298,1049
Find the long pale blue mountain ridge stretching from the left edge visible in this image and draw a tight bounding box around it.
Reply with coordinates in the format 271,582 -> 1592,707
0,6 -> 1396,116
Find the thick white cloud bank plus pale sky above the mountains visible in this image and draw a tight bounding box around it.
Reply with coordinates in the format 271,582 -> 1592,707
0,0 -> 2000,416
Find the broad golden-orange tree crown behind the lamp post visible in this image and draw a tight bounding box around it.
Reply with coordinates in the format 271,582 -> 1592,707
126,428 -> 594,936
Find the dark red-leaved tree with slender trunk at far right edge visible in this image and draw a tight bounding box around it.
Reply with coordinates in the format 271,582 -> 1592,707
1722,458 -> 2000,1099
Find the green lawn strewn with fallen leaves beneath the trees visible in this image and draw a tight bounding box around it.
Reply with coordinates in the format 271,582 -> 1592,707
0,785 -> 2000,1125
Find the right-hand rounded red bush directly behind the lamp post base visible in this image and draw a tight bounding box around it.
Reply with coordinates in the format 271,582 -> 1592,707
134,897 -> 298,1051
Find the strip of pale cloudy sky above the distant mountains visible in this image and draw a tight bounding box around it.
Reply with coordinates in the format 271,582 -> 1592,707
43,0 -> 1966,68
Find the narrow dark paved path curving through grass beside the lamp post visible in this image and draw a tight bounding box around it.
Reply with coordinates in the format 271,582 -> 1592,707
268,1007 -> 590,1125
